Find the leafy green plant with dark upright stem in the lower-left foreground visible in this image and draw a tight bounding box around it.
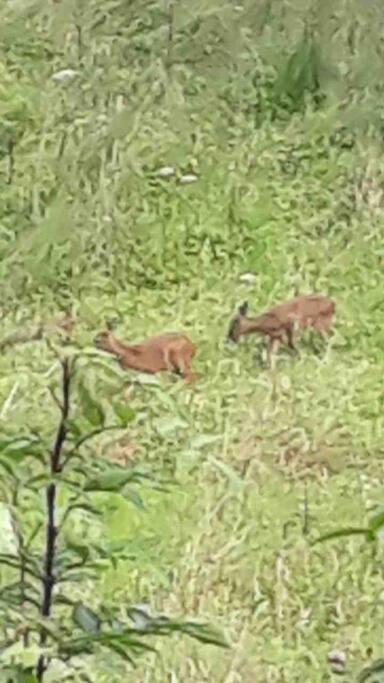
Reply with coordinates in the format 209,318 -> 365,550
0,355 -> 225,683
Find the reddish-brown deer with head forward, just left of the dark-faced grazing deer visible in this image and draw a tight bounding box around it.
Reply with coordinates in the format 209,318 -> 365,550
94,324 -> 196,383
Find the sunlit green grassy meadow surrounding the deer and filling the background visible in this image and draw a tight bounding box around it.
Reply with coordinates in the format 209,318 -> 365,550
0,0 -> 384,683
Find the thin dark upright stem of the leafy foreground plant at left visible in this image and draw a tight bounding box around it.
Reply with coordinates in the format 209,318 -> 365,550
36,359 -> 71,681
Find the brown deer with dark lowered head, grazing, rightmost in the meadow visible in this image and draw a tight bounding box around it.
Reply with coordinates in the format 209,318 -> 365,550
227,294 -> 335,366
